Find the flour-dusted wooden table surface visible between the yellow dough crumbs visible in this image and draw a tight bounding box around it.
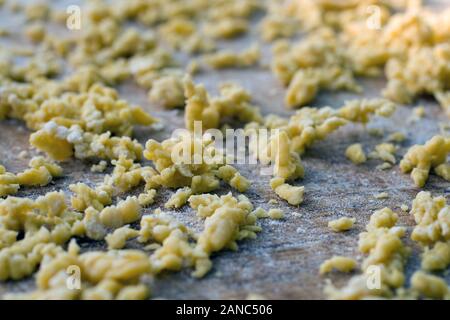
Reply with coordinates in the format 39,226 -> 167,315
0,1 -> 450,299
